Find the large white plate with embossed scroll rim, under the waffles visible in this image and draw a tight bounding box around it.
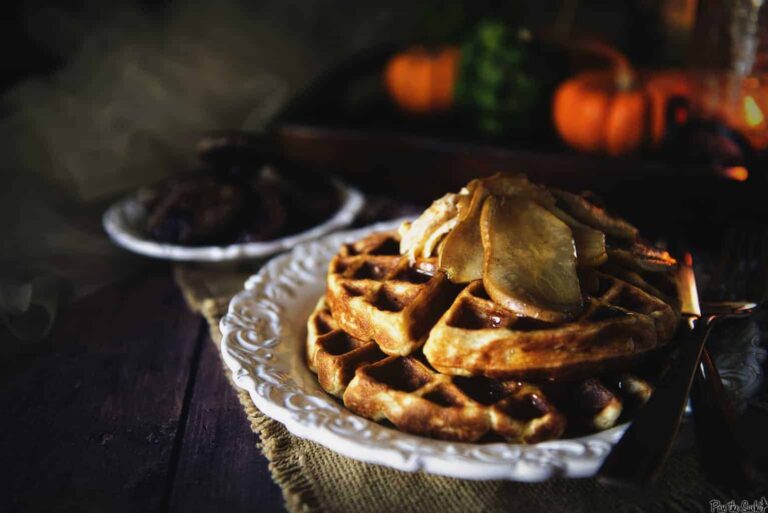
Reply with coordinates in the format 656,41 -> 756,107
221,221 -> 626,481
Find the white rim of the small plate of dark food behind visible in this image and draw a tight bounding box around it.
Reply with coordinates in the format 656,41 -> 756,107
102,181 -> 364,262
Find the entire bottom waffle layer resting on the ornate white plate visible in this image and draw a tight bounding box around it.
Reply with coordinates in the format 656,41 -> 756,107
306,298 -> 652,443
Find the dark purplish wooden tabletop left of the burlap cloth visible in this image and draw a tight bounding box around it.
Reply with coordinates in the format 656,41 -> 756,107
0,267 -> 284,513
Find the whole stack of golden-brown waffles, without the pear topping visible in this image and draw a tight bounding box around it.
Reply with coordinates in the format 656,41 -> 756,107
306,232 -> 678,443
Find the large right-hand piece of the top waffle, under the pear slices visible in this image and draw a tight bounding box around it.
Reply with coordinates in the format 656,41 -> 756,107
424,272 -> 679,379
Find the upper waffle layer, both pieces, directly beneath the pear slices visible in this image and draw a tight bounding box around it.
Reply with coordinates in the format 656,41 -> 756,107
327,232 -> 679,380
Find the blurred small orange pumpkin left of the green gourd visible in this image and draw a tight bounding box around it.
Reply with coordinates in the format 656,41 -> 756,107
384,46 -> 460,114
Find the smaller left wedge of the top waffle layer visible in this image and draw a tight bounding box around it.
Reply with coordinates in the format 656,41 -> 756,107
327,232 -> 459,355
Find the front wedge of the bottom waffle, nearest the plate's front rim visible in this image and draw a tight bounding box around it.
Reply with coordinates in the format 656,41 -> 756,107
344,356 -> 565,443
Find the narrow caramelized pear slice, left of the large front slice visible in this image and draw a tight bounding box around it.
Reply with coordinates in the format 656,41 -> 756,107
440,186 -> 488,283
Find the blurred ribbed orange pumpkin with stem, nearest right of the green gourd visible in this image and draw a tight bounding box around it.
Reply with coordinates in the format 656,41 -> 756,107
552,43 -> 690,156
